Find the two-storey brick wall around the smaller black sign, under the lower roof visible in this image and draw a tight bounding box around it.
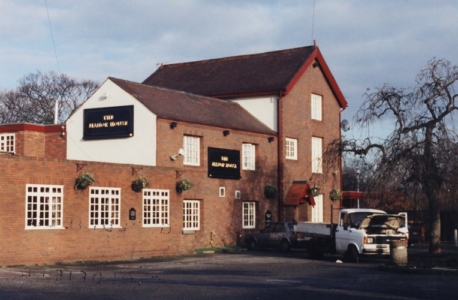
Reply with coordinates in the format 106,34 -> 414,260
157,120 -> 278,248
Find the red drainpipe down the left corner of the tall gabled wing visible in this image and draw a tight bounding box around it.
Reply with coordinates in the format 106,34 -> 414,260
277,91 -> 285,221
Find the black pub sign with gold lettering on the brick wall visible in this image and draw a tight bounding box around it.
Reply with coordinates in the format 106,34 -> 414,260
208,148 -> 240,179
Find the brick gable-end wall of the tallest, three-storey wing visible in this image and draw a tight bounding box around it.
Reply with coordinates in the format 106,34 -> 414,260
280,63 -> 340,222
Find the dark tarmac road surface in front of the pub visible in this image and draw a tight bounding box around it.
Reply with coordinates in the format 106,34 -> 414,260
0,246 -> 458,300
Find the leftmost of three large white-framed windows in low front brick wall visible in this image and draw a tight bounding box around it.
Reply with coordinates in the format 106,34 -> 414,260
25,184 -> 64,229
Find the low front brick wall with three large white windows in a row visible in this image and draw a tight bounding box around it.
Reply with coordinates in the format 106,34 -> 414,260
0,155 -> 180,266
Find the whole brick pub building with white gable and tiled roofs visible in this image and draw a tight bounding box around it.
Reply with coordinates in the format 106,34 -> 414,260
0,45 -> 347,266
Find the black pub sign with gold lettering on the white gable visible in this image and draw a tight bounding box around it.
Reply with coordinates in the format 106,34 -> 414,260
83,105 -> 134,140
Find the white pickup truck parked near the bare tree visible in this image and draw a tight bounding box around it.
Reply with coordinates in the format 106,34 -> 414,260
294,208 -> 408,262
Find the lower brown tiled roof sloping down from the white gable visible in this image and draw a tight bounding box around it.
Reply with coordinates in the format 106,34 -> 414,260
108,77 -> 276,134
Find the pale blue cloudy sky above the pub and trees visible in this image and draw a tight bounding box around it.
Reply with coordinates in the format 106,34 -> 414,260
0,0 -> 458,137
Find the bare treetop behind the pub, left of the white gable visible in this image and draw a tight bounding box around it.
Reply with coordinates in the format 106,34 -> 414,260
0,71 -> 99,124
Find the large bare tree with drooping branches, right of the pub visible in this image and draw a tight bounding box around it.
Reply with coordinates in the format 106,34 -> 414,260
325,59 -> 458,253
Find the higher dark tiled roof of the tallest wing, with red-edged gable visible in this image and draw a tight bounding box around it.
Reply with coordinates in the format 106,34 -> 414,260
143,46 -> 316,97
